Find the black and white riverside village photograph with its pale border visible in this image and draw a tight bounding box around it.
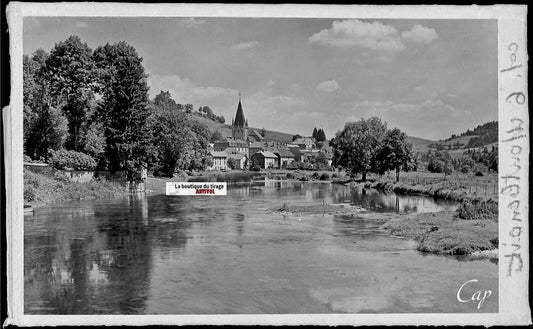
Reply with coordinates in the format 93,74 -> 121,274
4,4 -> 531,324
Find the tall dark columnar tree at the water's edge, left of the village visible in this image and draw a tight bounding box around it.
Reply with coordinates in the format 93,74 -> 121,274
93,41 -> 153,182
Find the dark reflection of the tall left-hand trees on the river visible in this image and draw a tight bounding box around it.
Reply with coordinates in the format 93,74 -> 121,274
24,196 -> 190,314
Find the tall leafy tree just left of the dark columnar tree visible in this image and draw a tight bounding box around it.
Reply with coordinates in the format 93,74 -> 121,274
43,35 -> 95,151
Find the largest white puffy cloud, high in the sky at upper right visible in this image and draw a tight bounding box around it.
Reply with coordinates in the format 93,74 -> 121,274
309,19 -> 437,52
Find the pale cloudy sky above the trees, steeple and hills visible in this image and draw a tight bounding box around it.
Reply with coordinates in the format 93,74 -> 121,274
23,17 -> 498,140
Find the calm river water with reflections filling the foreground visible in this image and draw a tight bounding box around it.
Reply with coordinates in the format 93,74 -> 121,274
24,182 -> 498,314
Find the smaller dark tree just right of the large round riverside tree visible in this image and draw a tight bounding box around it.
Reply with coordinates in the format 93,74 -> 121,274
377,128 -> 413,182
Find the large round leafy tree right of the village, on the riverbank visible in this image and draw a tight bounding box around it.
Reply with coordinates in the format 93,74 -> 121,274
330,117 -> 387,181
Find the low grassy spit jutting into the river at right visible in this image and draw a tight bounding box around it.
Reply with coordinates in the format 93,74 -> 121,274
383,212 -> 498,255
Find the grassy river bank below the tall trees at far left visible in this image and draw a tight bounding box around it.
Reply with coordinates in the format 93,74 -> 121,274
24,170 -> 127,207
